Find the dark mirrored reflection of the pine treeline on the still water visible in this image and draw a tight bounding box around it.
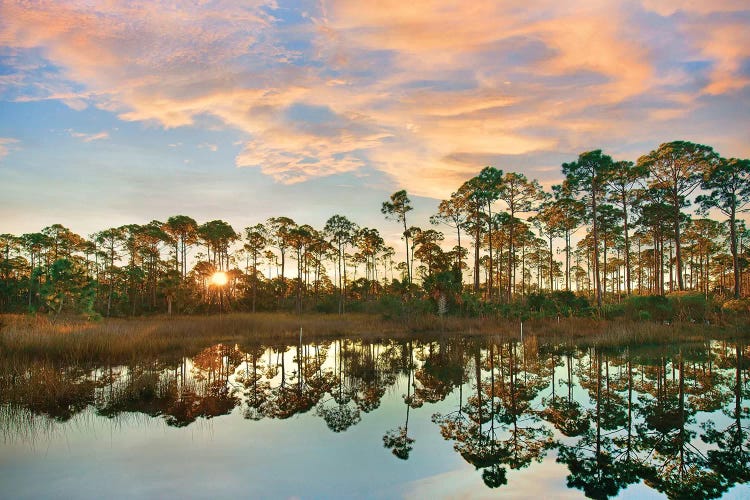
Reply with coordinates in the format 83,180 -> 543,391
0,337 -> 750,498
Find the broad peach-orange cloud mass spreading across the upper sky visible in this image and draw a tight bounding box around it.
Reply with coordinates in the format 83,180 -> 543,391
0,0 -> 750,196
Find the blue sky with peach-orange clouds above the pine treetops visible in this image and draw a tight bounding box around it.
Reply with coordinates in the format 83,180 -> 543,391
0,0 -> 750,246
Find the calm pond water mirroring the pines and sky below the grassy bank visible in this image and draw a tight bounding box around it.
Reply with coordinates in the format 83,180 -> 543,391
0,337 -> 750,498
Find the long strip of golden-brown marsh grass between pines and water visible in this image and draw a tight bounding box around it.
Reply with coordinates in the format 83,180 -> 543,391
0,313 -> 748,363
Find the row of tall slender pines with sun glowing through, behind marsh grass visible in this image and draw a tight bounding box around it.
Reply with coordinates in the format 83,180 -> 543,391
0,141 -> 750,320
